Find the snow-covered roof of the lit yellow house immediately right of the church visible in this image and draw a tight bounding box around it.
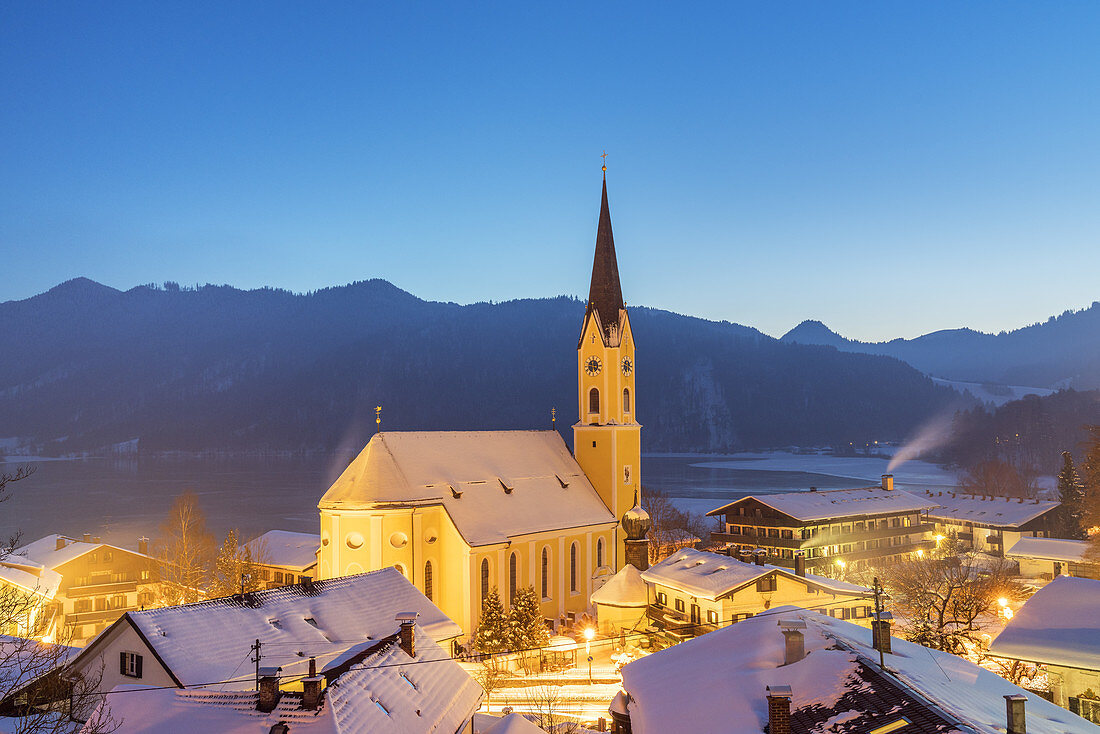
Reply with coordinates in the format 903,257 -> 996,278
642,548 -> 871,601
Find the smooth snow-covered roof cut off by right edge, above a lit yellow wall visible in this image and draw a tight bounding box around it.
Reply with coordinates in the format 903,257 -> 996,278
989,576 -> 1100,670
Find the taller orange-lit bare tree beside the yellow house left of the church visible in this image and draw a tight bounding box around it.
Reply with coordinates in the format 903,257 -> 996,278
154,491 -> 215,606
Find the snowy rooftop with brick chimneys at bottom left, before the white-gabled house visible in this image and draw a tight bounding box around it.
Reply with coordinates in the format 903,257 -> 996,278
79,614 -> 484,734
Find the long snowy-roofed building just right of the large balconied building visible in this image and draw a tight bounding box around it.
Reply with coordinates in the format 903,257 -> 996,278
922,490 -> 1062,556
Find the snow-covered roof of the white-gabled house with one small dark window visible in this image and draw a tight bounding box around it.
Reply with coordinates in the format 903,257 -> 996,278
73,568 -> 462,689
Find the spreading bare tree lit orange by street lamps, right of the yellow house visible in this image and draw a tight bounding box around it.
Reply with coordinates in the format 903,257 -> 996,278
879,554 -> 1027,654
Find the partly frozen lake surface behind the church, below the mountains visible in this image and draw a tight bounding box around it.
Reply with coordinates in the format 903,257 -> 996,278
0,452 -> 955,547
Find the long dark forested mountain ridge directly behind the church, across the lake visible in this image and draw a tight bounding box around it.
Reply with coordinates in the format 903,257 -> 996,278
0,278 -> 967,454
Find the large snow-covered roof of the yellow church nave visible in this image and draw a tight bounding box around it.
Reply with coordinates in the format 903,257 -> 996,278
318,430 -> 616,546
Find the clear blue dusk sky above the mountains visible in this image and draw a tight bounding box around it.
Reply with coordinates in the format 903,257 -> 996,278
0,1 -> 1100,339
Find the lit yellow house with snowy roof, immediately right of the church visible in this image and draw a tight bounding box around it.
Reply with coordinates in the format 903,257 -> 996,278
640,548 -> 872,638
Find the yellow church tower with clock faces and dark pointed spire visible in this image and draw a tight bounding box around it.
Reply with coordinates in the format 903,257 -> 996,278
573,167 -> 641,571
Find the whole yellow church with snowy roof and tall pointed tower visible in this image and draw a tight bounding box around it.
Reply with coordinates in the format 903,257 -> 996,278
318,167 -> 646,635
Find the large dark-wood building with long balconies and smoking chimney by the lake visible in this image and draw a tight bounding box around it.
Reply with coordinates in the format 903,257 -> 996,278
707,474 -> 935,574
